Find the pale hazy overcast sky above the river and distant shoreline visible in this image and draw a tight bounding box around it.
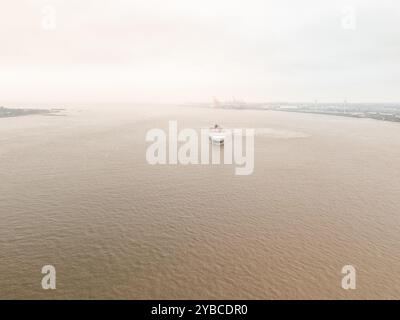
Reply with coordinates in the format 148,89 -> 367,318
0,0 -> 400,105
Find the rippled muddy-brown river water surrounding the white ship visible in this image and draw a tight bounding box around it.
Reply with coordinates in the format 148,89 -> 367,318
0,106 -> 400,299
